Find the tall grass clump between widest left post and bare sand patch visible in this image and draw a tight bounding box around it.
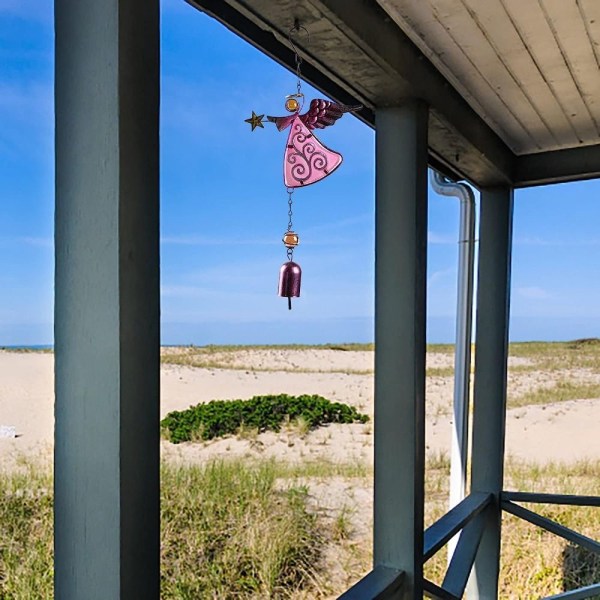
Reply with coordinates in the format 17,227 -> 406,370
161,461 -> 321,599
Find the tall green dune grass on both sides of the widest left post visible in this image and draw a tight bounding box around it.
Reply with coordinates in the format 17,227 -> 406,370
0,461 -> 323,600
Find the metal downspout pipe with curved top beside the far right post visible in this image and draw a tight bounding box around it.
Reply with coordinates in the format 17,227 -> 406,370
430,170 -> 475,560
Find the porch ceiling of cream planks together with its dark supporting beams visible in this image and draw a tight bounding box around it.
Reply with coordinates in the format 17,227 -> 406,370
188,0 -> 600,186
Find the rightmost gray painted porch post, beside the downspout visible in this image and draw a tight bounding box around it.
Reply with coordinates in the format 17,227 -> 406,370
468,187 -> 513,600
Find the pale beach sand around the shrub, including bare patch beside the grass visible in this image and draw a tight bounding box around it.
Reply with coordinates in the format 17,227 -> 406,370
0,348 -> 600,598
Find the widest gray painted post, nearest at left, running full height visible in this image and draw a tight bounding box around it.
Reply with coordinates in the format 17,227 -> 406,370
54,0 -> 160,600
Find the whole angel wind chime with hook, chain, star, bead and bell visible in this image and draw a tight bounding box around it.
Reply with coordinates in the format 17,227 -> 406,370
246,22 -> 362,310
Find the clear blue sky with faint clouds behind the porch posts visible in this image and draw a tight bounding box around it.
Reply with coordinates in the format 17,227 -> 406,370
0,0 -> 600,345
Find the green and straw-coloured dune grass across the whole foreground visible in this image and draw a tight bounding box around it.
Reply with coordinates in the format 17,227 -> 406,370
0,454 -> 600,600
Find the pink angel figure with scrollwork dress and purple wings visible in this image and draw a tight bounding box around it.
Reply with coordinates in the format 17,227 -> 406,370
267,99 -> 362,188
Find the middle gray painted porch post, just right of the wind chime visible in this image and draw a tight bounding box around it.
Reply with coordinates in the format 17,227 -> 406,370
374,102 -> 428,599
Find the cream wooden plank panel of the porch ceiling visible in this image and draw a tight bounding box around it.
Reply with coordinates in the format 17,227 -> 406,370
379,0 -> 600,154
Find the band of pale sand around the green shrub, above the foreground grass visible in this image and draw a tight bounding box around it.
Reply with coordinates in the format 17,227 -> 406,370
0,348 -> 600,466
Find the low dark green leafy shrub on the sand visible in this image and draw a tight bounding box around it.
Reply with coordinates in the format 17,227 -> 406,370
161,394 -> 369,444
